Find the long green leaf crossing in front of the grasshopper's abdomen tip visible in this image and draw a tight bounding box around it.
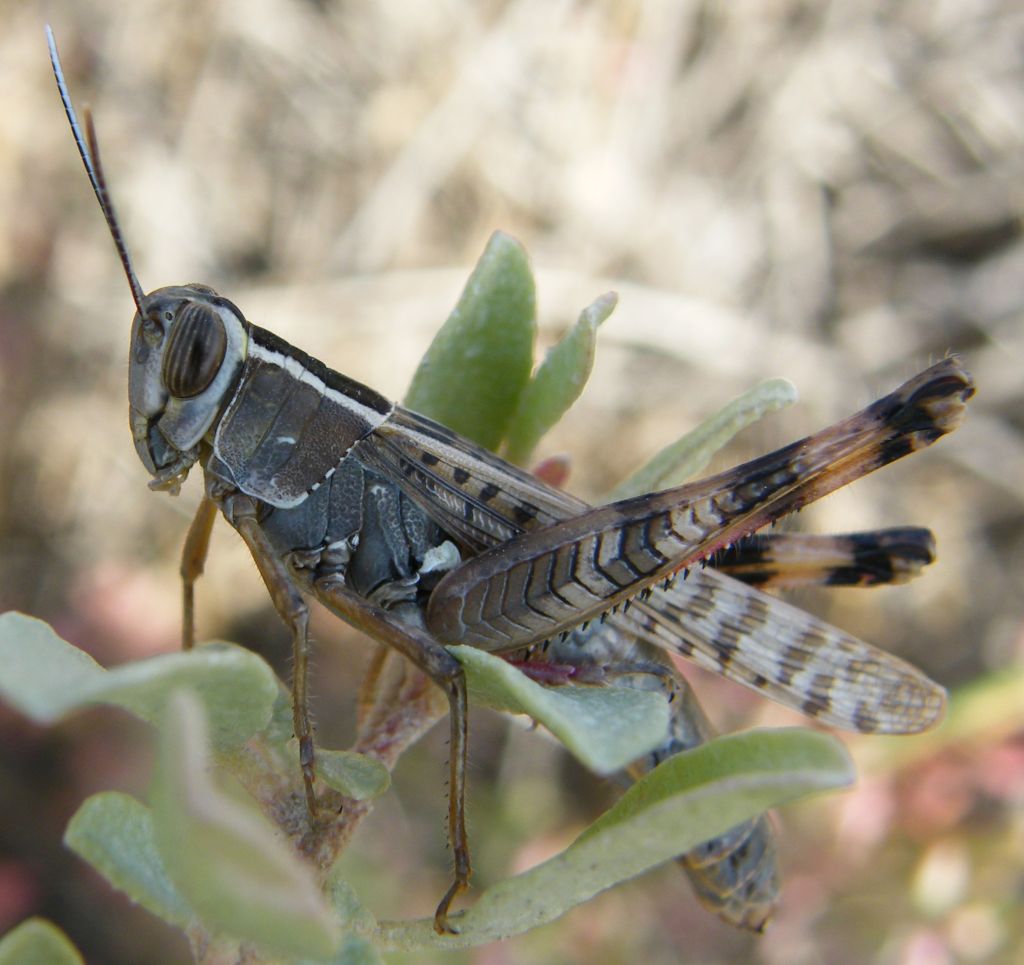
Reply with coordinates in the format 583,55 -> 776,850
381,728 -> 853,950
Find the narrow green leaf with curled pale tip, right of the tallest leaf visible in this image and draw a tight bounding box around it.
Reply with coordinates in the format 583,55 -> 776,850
506,292 -> 618,465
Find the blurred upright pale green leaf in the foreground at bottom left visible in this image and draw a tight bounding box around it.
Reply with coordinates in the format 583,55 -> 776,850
153,690 -> 341,959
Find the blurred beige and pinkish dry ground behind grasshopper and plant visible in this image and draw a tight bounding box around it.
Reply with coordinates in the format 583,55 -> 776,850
0,0 -> 1024,965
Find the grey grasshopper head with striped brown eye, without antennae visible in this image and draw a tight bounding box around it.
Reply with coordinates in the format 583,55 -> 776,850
128,285 -> 247,491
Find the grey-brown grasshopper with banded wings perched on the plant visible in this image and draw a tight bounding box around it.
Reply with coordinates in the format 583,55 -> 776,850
47,29 -> 974,932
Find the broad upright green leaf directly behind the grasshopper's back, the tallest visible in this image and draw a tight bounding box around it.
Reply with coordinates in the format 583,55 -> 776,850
404,232 -> 537,450
